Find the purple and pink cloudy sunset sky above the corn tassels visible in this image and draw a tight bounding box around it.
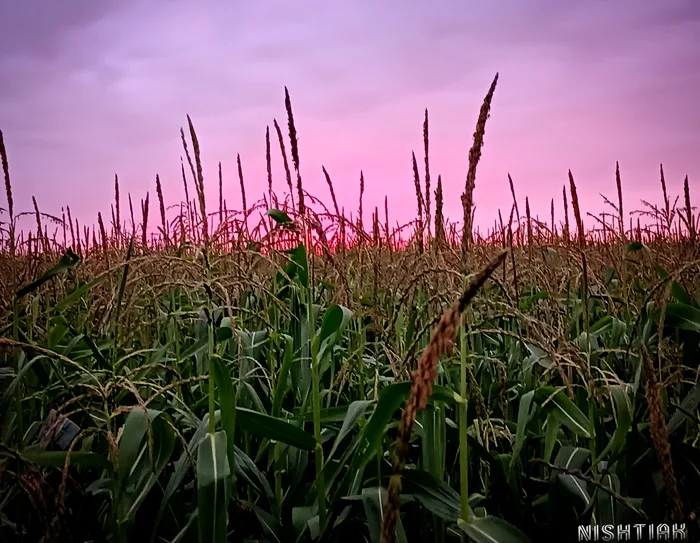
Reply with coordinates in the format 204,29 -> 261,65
0,0 -> 700,236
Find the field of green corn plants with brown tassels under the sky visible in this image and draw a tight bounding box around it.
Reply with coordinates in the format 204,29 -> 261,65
0,80 -> 700,543
